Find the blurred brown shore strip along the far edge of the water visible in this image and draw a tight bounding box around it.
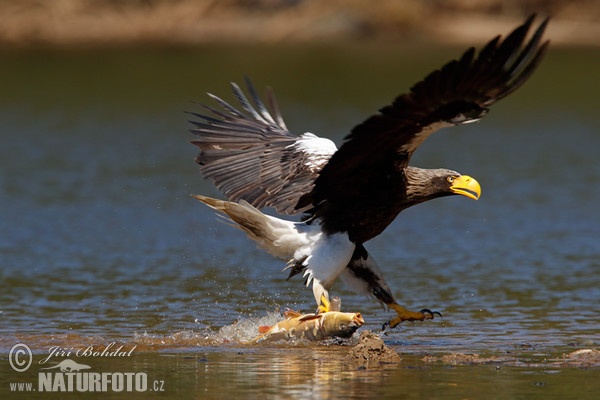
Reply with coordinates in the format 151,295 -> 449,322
0,0 -> 600,48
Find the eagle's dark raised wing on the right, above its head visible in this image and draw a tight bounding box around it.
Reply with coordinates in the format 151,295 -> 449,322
308,15 -> 548,209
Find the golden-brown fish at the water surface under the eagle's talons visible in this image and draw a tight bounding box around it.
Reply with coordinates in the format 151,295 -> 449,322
251,310 -> 365,343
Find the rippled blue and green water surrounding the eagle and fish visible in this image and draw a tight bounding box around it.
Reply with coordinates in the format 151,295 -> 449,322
0,46 -> 600,398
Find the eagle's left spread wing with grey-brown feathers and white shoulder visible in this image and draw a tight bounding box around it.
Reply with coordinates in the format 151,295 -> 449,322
191,79 -> 337,214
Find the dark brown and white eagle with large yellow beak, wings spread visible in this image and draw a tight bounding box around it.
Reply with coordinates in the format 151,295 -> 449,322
190,14 -> 549,328
